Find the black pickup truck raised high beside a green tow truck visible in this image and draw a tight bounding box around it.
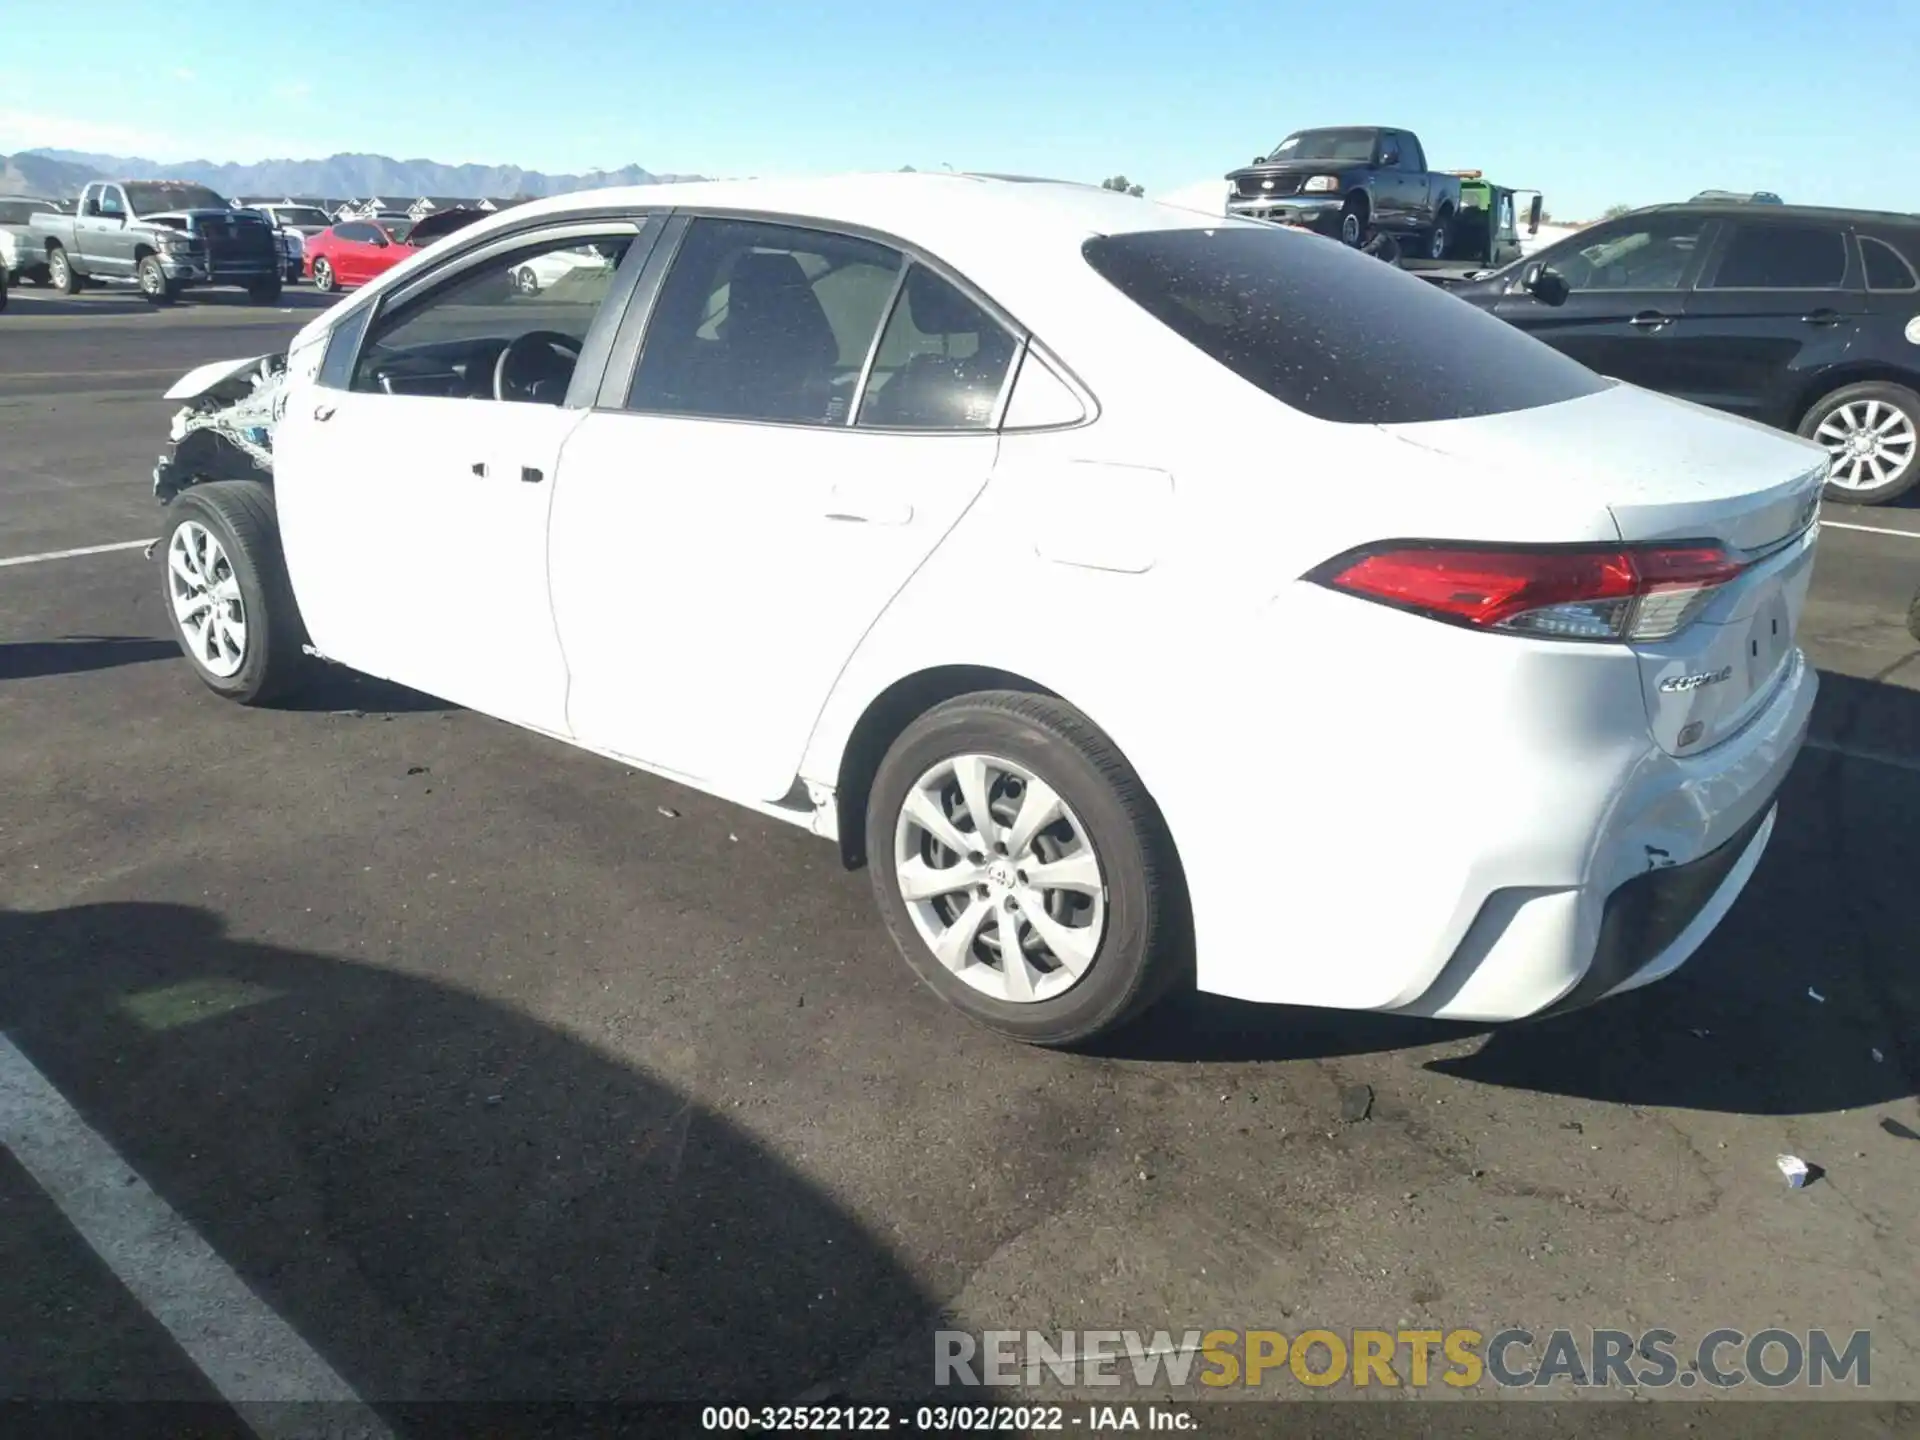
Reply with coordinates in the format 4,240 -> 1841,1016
1227,125 -> 1459,259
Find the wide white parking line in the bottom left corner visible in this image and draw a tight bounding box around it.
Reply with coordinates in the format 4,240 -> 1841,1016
0,1035 -> 392,1440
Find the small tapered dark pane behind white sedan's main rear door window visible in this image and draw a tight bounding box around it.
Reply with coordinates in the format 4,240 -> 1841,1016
856,265 -> 1018,430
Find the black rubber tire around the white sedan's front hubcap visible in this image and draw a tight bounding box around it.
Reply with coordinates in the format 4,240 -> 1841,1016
157,480 -> 307,705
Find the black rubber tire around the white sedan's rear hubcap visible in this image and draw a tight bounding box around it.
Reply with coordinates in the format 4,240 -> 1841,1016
866,691 -> 1190,1046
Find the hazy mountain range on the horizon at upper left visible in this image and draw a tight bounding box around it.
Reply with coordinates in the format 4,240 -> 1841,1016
0,150 -> 701,200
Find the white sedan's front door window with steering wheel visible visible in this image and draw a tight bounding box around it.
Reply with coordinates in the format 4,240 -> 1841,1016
349,232 -> 634,405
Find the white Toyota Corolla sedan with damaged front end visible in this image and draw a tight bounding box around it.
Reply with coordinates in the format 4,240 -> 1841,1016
156,175 -> 1826,1044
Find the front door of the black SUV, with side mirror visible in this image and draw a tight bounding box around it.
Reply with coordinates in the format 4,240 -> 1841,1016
1494,211 -> 1716,392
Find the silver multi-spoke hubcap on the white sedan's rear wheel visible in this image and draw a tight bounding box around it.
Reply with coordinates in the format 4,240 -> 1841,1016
893,755 -> 1106,1004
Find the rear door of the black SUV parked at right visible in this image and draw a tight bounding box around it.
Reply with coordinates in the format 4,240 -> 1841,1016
1668,217 -> 1866,424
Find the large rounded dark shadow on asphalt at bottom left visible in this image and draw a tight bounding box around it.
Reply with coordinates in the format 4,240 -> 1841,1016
0,904 -> 935,1413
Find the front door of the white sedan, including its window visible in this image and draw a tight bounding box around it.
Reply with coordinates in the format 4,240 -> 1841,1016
275,221 -> 643,735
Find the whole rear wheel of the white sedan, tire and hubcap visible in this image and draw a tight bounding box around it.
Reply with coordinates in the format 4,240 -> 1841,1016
866,691 -> 1187,1044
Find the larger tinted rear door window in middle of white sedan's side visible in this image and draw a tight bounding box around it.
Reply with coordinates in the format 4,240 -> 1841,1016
628,219 -> 904,424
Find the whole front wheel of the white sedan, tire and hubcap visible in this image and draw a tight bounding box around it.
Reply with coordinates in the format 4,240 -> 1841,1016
161,480 -> 305,705
